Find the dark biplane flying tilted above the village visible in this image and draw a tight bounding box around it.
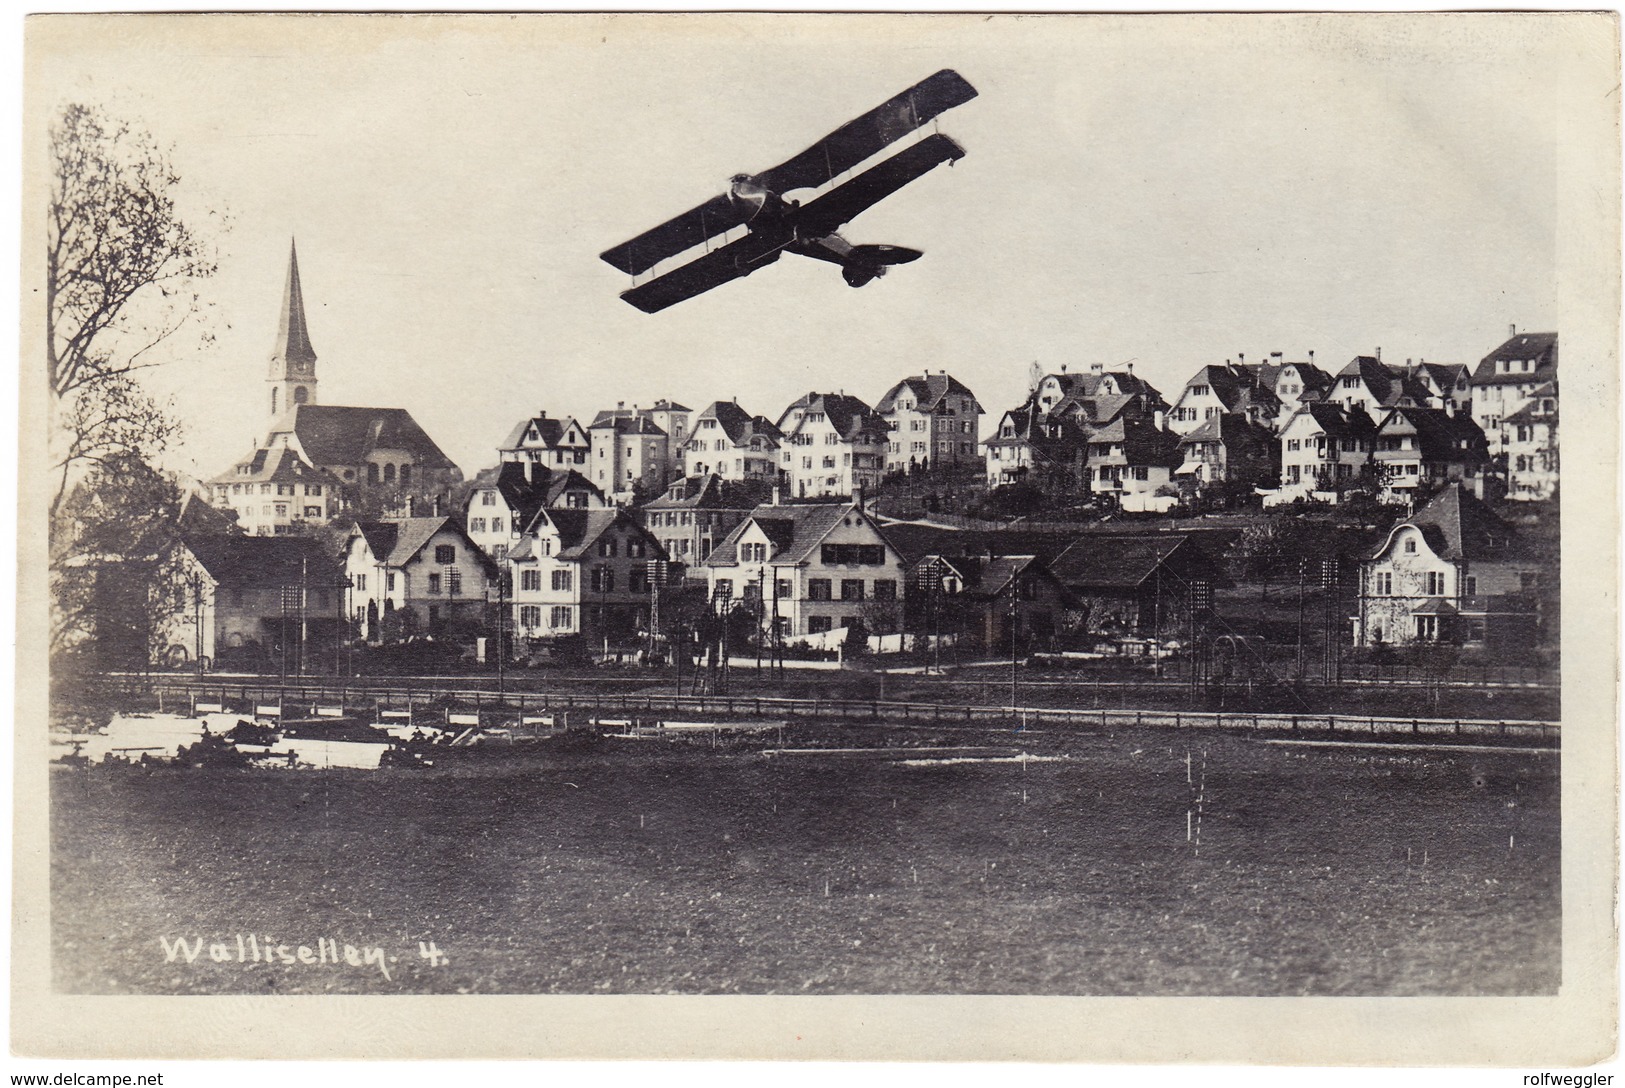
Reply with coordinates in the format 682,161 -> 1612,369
601,68 -> 977,313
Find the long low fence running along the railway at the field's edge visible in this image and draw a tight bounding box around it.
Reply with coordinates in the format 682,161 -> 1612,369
125,677 -> 1558,742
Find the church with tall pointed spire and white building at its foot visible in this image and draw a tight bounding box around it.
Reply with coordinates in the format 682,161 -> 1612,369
208,247 -> 463,536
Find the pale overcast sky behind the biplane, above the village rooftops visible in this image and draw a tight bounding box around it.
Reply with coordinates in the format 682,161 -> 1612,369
29,16 -> 1563,474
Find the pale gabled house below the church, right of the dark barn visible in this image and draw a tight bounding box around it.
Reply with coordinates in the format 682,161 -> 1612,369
345,516 -> 497,641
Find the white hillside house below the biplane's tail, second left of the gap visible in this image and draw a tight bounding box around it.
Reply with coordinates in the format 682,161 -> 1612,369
777,393 -> 891,499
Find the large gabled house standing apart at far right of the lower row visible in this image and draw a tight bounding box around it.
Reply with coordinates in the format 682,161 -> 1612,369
1354,484 -> 1542,651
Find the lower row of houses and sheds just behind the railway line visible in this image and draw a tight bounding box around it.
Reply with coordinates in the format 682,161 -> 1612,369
152,477 -> 1542,666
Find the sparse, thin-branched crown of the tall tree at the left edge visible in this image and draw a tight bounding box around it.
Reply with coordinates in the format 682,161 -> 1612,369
46,104 -> 215,516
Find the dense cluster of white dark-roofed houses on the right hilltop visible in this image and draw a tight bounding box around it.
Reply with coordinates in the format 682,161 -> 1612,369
983,330 -> 1558,508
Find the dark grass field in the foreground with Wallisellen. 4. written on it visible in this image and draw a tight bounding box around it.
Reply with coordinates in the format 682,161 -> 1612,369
52,732 -> 1560,994
